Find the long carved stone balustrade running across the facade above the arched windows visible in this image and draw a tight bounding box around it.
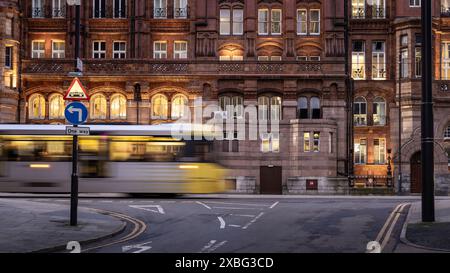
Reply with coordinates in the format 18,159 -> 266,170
23,59 -> 344,77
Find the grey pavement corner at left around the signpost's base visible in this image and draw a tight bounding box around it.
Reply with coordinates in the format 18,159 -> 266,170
0,198 -> 125,253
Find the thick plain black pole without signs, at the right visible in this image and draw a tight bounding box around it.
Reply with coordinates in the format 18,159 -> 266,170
421,0 -> 435,222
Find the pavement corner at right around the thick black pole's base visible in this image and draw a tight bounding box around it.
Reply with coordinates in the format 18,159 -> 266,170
396,200 -> 450,252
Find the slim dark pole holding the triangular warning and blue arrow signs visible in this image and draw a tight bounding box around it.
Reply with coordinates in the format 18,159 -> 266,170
70,5 -> 81,226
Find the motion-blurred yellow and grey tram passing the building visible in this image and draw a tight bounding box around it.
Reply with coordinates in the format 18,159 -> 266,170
0,124 -> 226,194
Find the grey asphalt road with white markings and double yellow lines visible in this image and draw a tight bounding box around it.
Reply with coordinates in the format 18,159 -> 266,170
25,196 -> 414,253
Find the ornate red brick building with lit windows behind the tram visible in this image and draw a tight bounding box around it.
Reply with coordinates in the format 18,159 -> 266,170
0,0 -> 450,195
